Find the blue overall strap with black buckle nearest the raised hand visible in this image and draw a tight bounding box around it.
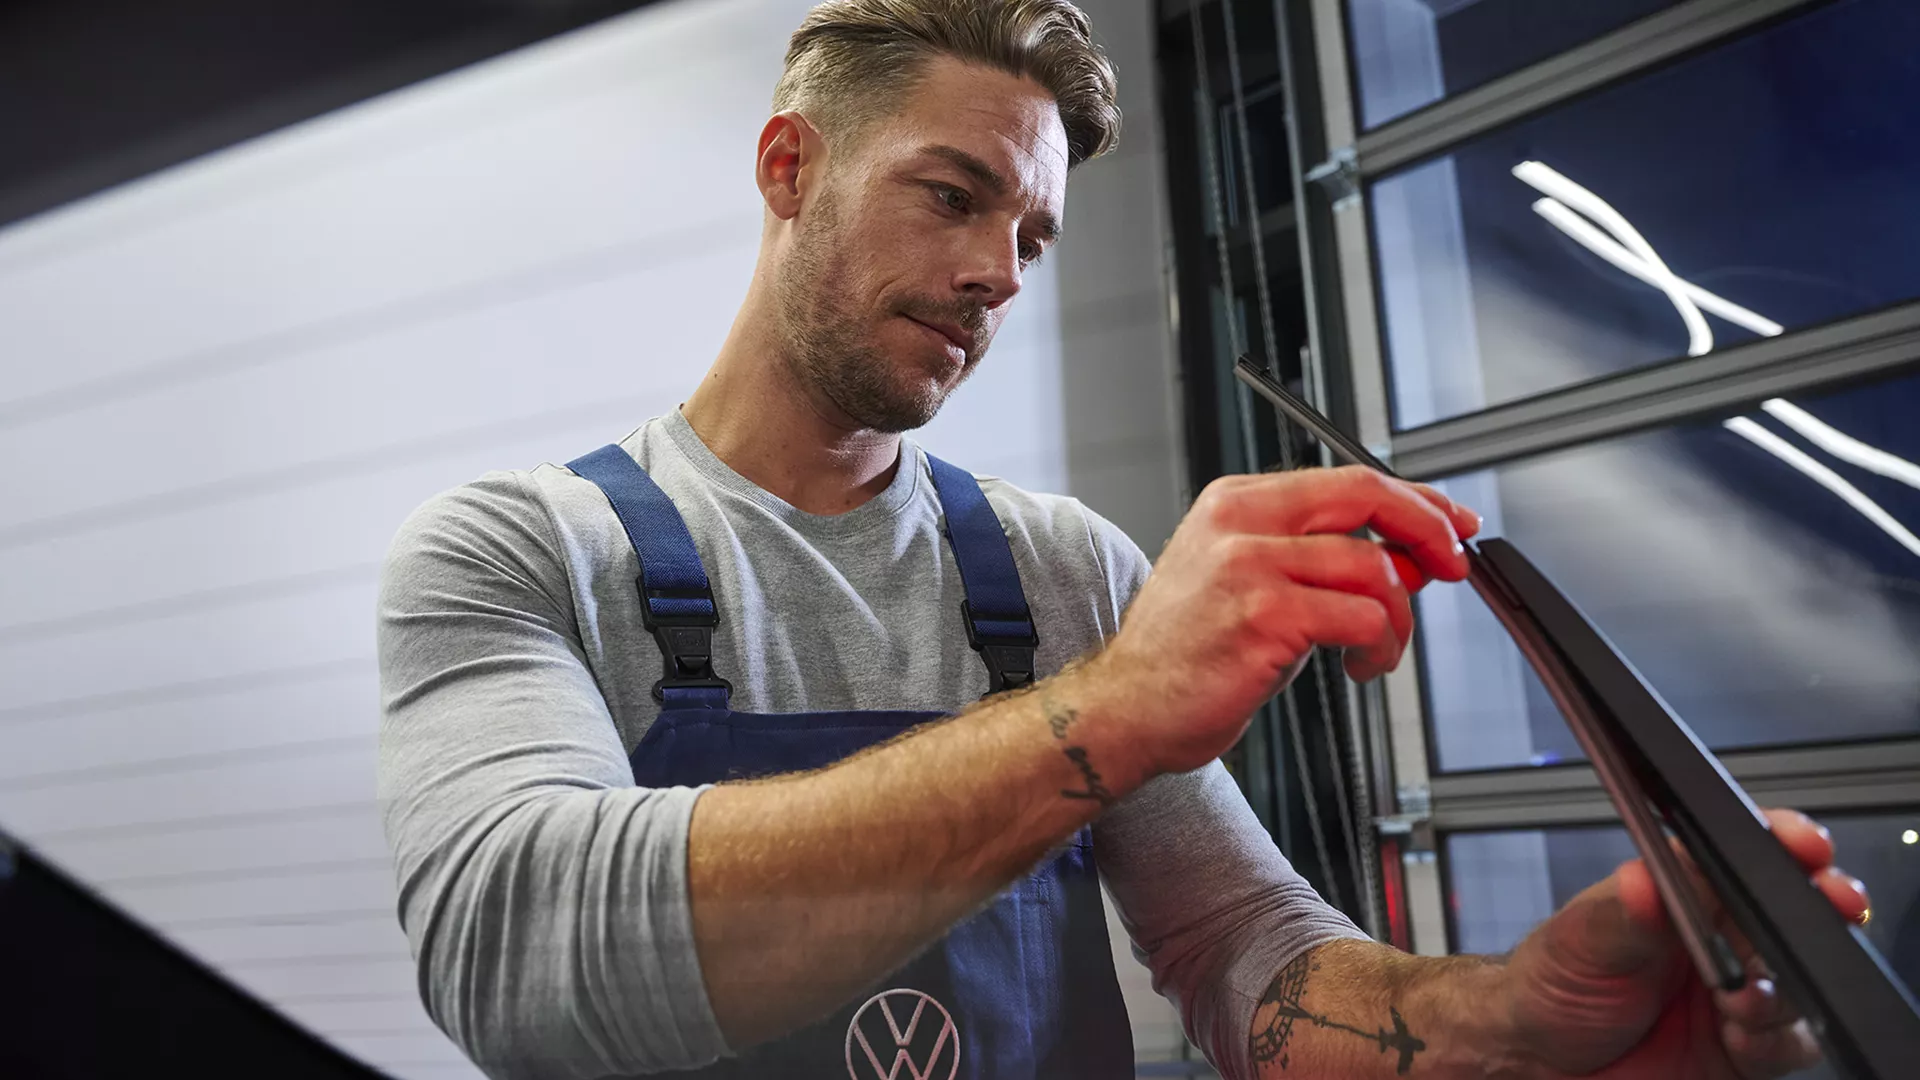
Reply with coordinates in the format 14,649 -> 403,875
927,454 -> 1041,694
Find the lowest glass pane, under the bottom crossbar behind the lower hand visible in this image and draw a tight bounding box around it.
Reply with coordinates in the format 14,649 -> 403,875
1444,809 -> 1920,1080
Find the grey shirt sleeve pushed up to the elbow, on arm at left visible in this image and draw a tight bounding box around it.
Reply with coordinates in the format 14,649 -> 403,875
378,475 -> 726,1080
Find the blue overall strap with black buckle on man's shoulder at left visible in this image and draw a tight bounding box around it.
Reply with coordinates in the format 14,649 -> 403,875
566,444 -> 733,709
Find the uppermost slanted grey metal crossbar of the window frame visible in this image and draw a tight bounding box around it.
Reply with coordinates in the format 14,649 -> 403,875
1342,0 -> 1832,181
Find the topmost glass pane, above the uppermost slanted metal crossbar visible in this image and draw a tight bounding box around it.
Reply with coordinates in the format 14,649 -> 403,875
1348,0 -> 1680,127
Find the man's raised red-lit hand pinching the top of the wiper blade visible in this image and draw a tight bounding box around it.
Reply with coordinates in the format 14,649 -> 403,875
1089,467 -> 1480,773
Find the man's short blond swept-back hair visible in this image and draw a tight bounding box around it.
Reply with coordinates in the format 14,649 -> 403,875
774,0 -> 1119,169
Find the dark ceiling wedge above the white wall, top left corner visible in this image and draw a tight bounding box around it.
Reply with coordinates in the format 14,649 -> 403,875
0,0 -> 647,225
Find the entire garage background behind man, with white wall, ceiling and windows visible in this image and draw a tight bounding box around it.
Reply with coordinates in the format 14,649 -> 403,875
0,0 -> 1920,1078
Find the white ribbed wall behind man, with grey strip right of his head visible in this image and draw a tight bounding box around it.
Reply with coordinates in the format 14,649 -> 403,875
0,0 -> 1183,1076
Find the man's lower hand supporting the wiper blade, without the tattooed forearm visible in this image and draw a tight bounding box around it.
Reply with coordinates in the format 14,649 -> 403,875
1507,811 -> 1868,1080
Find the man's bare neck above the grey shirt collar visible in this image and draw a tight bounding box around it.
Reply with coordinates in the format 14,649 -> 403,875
680,284 -> 900,513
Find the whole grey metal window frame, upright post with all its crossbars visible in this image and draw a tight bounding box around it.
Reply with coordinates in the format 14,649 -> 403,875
1275,0 -> 1920,953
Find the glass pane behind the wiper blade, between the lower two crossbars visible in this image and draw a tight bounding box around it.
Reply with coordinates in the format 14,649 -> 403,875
1419,365 -> 1920,771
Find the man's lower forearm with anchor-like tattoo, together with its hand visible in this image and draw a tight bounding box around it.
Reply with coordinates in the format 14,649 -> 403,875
1231,811 -> 1866,1080
